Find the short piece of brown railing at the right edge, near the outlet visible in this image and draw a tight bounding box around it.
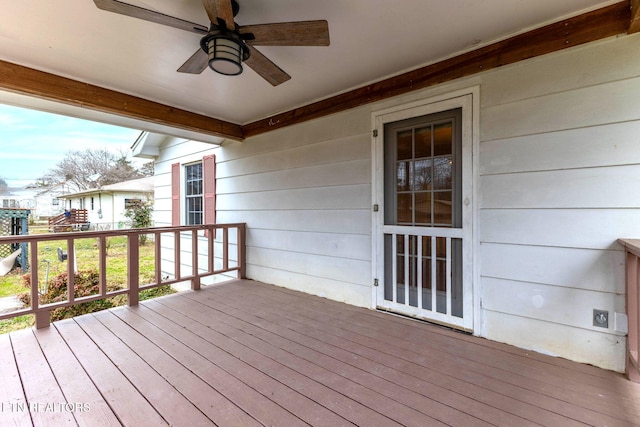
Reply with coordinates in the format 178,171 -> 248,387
619,239 -> 640,383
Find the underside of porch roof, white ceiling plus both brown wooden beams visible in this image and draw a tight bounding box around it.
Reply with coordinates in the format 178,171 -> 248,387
0,0 -> 640,143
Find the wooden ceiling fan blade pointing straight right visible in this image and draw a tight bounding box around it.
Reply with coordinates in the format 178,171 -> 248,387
240,20 -> 329,46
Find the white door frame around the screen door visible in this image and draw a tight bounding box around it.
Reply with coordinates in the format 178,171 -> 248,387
371,86 -> 481,334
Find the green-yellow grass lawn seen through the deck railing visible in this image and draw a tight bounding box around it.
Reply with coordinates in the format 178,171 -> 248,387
0,236 -> 170,333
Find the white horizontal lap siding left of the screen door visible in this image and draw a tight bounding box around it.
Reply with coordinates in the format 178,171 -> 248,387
156,110 -> 371,306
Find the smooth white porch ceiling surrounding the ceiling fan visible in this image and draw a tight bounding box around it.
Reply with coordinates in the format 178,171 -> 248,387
0,0 -> 616,130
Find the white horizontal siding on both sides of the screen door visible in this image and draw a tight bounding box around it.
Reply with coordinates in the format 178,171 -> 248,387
156,35 -> 640,370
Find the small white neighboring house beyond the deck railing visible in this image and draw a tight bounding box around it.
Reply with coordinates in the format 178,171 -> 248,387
61,176 -> 154,230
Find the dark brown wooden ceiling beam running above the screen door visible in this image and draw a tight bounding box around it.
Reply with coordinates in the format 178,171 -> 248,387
243,0 -> 640,138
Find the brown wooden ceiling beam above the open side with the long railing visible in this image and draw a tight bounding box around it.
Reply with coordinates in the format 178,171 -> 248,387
0,60 -> 243,140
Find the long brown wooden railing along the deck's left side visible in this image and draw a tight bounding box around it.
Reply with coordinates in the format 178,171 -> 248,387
0,223 -> 246,328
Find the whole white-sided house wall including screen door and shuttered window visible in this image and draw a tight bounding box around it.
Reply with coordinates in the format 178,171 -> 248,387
134,34 -> 640,371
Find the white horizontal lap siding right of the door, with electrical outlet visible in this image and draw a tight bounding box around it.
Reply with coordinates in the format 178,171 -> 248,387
479,36 -> 640,370
